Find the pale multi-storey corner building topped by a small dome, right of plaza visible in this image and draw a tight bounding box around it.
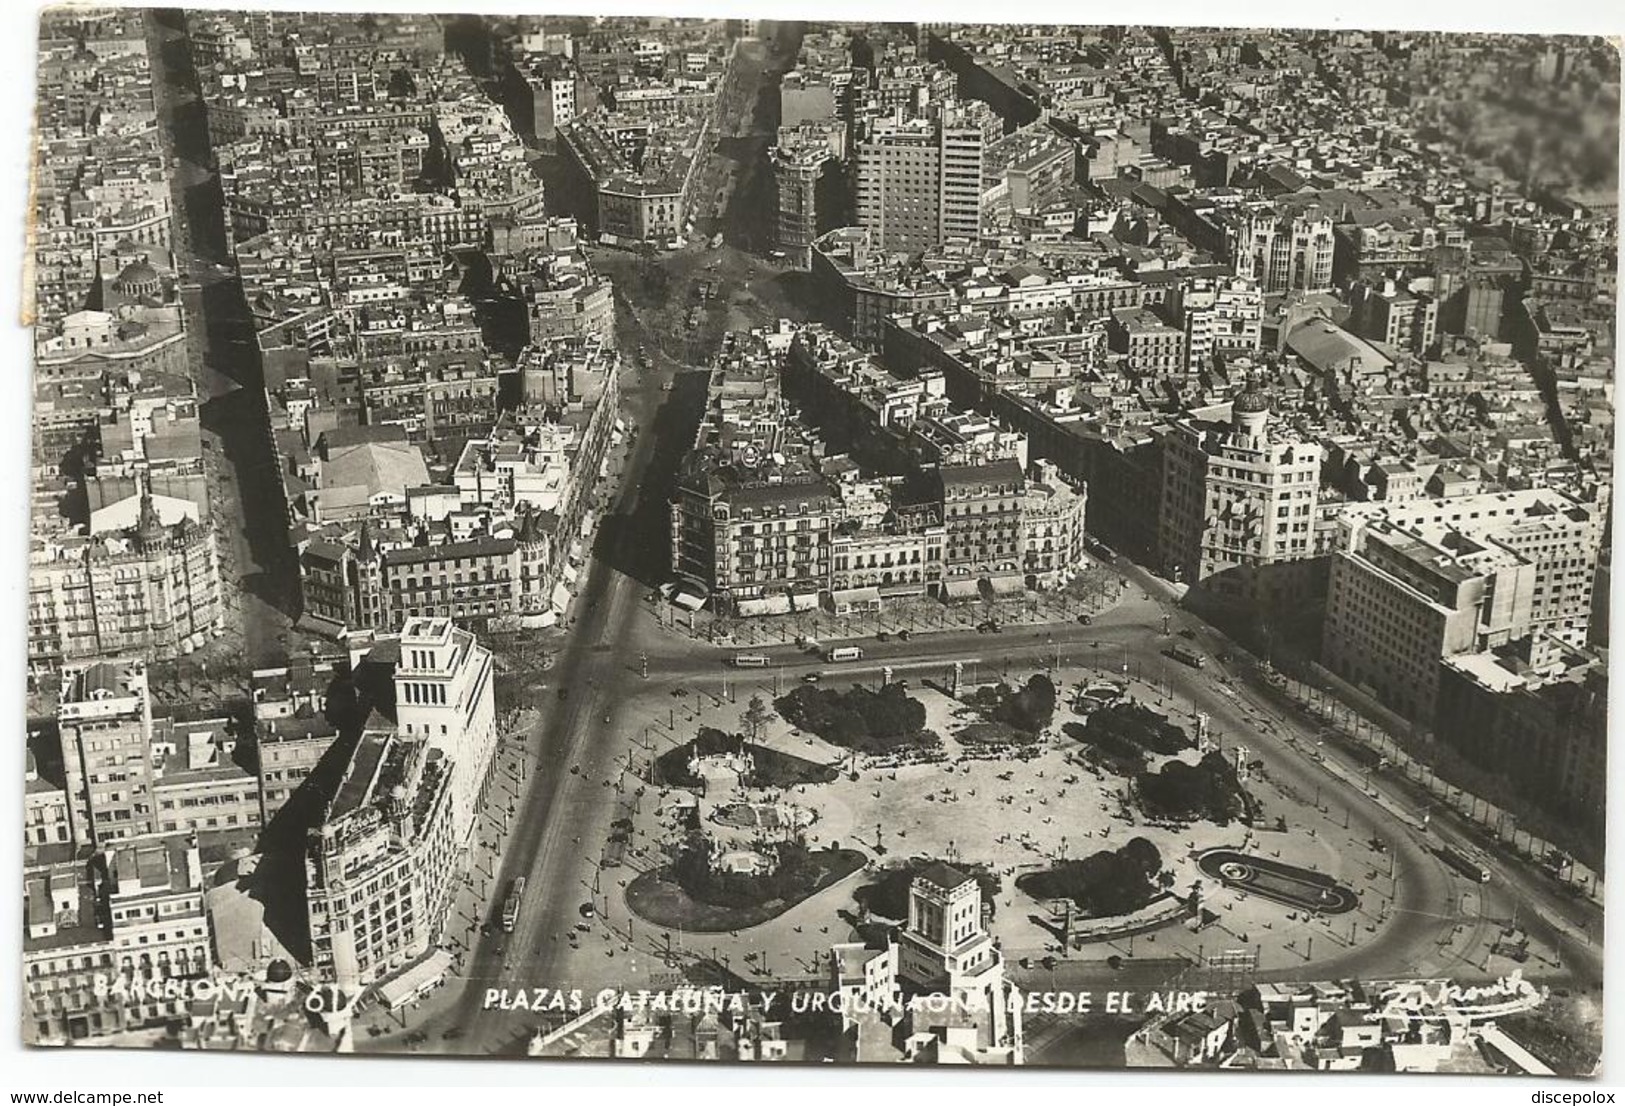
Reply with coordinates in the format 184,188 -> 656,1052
1159,388 -> 1321,590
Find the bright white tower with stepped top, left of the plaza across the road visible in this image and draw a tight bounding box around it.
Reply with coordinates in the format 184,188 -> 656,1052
395,619 -> 497,845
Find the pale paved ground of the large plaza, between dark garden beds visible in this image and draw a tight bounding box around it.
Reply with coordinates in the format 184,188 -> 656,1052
608,656 -> 1534,974
